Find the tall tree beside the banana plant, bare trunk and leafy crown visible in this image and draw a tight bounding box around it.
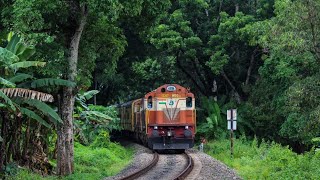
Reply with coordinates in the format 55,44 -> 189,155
4,0 -> 171,175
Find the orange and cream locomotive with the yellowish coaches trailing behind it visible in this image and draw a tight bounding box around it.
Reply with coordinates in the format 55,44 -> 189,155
120,84 -> 196,150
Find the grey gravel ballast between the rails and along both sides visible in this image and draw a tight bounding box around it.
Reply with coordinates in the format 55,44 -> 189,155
105,144 -> 242,180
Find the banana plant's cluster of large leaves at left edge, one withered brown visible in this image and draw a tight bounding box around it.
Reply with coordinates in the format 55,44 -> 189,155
0,32 -> 65,127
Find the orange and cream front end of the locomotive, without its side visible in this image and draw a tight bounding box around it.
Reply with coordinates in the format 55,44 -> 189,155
143,84 -> 196,150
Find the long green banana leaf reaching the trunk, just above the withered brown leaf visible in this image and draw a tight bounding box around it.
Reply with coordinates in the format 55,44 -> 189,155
31,78 -> 76,88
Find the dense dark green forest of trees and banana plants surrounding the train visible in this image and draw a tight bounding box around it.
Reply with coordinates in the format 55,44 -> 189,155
0,0 -> 320,178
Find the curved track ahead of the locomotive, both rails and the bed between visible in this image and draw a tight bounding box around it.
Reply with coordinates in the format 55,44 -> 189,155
122,153 -> 193,180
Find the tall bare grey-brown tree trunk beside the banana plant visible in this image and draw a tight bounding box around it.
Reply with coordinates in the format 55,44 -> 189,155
57,6 -> 88,176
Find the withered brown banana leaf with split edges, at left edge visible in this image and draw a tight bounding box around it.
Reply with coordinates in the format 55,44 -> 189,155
0,88 -> 53,102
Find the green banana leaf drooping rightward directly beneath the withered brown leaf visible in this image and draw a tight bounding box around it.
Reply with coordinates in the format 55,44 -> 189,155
20,99 -> 62,123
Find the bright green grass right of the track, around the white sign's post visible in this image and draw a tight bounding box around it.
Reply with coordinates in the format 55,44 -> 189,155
205,138 -> 320,179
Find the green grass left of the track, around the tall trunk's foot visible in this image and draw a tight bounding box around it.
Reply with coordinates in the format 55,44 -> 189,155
8,143 -> 133,180
